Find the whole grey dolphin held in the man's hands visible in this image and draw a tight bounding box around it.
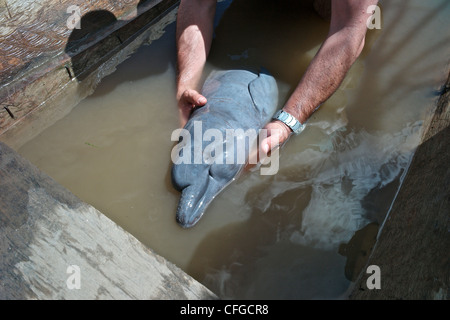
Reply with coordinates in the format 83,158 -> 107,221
172,70 -> 278,228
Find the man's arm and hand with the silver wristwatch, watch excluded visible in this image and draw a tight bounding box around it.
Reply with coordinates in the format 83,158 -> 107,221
261,0 -> 378,153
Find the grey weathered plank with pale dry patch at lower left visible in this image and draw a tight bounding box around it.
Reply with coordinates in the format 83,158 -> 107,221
0,143 -> 217,300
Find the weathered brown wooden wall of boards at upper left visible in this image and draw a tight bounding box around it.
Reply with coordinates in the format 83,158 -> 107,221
0,0 -> 178,149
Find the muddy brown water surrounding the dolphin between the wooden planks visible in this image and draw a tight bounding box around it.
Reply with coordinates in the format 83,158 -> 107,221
19,0 -> 450,299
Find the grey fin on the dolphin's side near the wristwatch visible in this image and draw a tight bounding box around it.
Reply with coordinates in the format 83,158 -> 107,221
248,68 -> 278,119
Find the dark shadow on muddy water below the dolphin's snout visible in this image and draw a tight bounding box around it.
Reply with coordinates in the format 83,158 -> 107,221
183,182 -> 360,300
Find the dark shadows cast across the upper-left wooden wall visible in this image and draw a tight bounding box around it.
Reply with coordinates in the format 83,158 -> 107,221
65,0 -> 175,97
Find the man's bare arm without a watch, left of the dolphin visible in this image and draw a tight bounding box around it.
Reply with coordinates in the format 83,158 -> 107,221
176,0 -> 216,127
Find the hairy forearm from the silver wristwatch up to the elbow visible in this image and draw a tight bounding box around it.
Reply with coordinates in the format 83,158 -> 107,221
283,29 -> 364,123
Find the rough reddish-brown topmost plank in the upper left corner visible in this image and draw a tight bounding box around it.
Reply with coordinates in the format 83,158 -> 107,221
0,0 -> 163,87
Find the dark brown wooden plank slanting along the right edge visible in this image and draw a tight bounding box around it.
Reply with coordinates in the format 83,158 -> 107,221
350,70 -> 450,300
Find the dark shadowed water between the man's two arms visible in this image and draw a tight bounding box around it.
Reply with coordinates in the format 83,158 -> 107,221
208,0 -> 329,87
